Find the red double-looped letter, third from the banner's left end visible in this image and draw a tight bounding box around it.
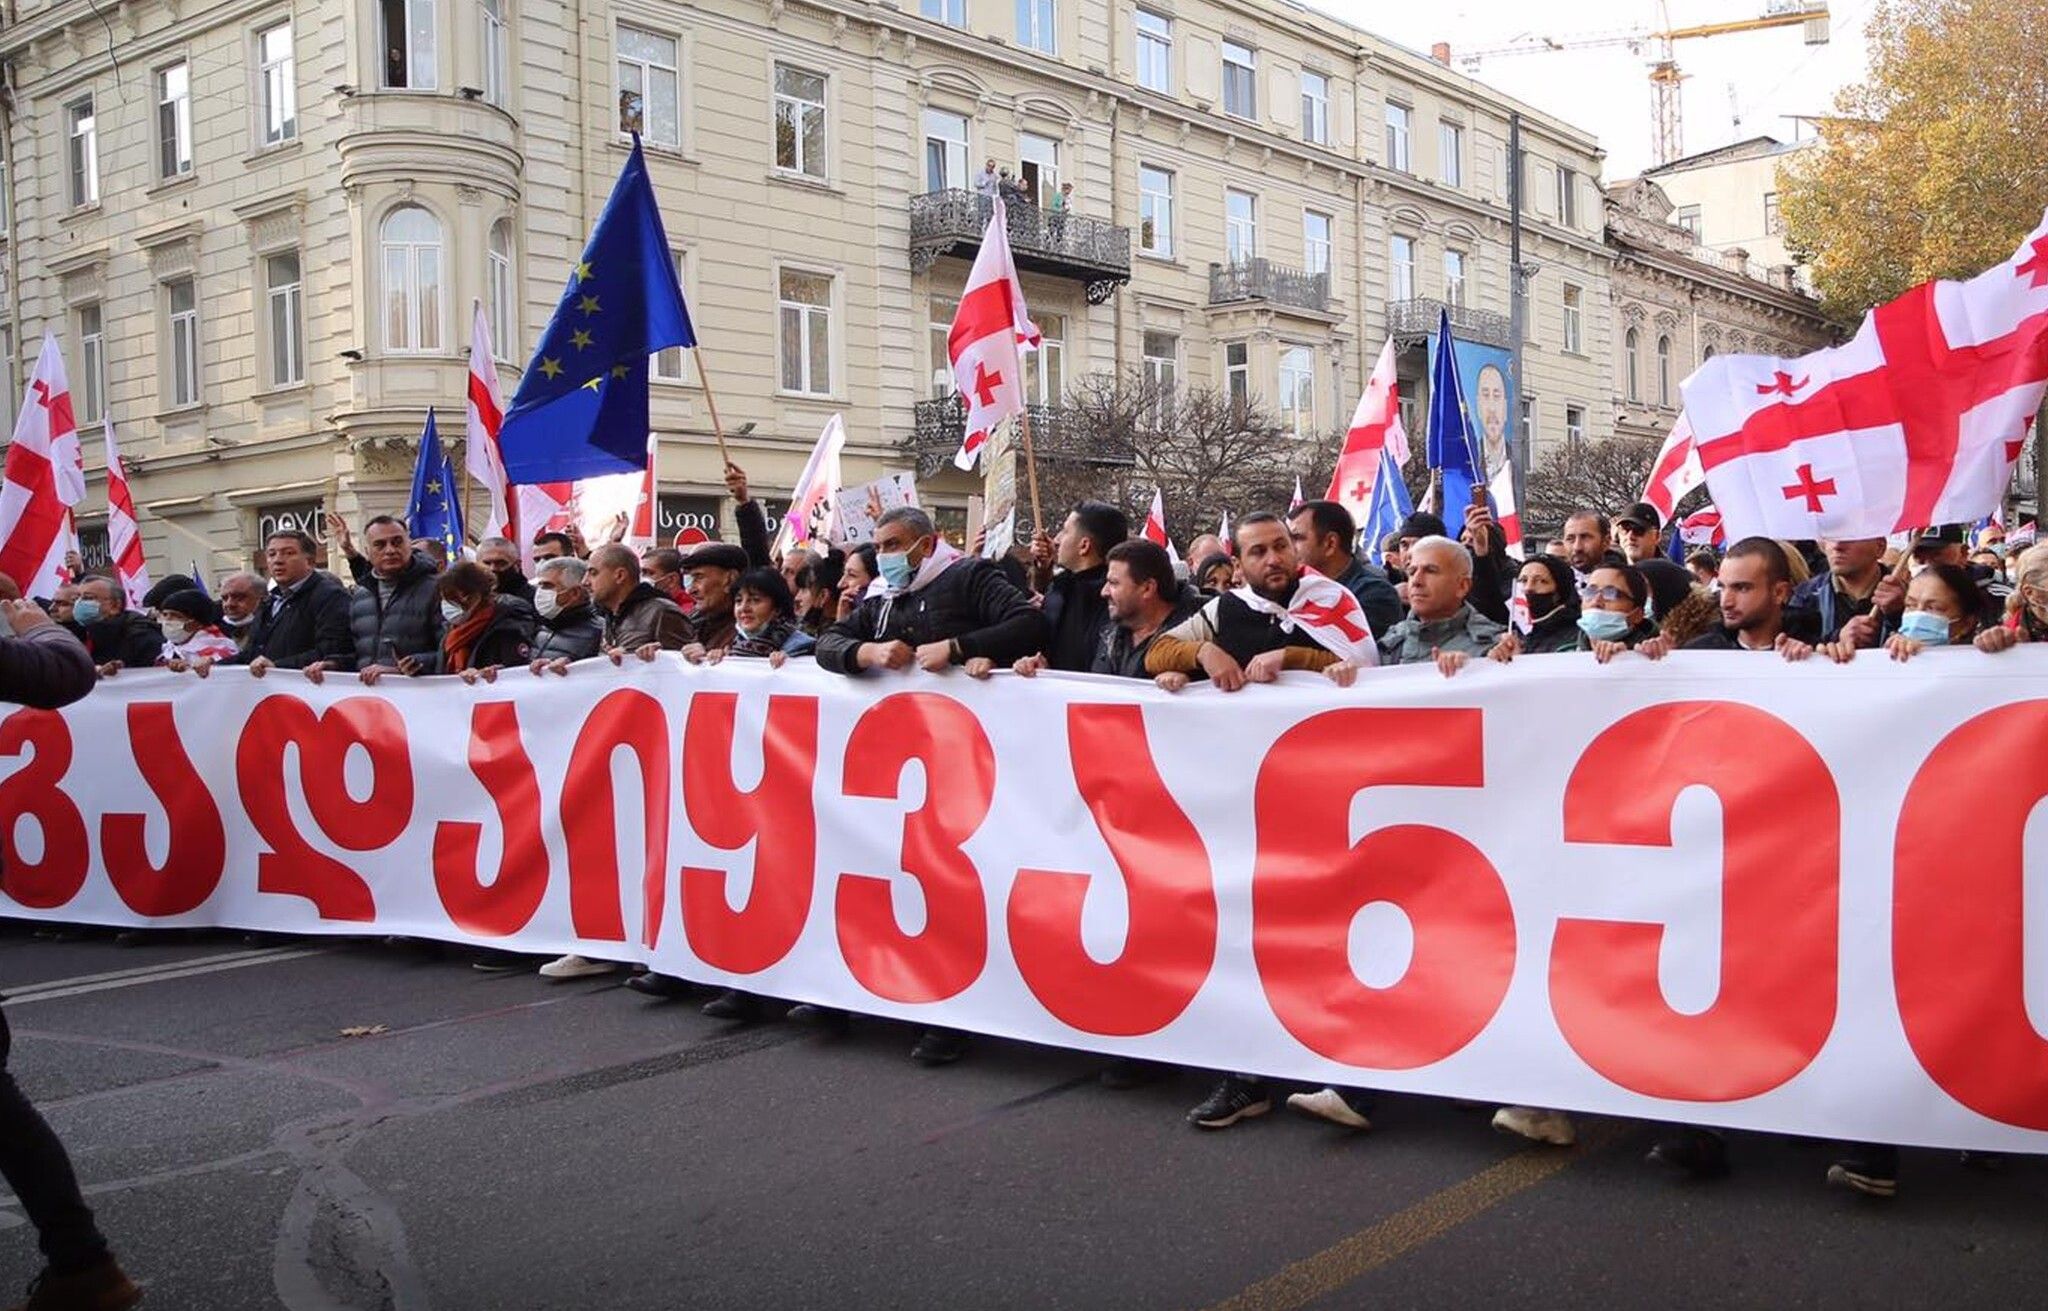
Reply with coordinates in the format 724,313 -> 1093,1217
236,696 -> 412,922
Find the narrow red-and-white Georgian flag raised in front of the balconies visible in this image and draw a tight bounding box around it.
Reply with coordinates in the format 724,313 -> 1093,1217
946,199 -> 1038,469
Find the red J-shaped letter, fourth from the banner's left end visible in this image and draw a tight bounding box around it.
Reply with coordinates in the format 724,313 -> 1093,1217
434,701 -> 547,938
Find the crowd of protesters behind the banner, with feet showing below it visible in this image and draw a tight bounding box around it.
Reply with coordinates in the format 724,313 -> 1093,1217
0,467 -> 2048,1311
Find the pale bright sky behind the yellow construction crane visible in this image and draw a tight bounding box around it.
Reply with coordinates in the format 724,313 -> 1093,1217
1303,0 -> 1874,182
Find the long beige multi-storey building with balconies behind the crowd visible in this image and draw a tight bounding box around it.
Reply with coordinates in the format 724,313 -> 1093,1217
0,0 -> 1614,572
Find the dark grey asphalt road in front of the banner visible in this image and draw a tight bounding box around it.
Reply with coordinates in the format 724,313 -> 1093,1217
0,922 -> 2048,1311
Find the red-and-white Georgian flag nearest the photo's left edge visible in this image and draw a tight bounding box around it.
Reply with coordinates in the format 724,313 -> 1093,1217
0,334 -> 86,596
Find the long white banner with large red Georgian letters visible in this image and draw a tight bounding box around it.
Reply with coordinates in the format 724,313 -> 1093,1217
0,647 -> 2048,1151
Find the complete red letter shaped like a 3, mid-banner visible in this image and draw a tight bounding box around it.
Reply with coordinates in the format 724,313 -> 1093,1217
836,692 -> 995,1002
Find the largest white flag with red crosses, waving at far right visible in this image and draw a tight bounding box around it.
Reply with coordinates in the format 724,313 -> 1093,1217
1683,217 -> 2048,541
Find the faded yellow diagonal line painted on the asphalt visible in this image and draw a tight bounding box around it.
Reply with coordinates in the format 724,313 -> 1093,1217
1208,1120 -> 1632,1311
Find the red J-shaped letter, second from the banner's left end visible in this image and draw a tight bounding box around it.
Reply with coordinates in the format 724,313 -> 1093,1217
100,701 -> 227,916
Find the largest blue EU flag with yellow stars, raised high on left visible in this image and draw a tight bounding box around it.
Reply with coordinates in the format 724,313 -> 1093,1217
498,137 -> 696,483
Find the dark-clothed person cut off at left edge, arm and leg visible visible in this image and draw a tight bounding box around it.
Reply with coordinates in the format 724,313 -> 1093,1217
0,598 -> 141,1311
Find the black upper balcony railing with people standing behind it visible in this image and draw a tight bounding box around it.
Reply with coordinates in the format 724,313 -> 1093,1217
909,191 -> 1130,305
